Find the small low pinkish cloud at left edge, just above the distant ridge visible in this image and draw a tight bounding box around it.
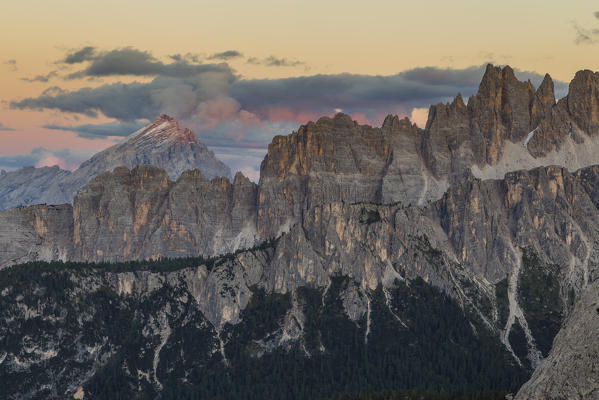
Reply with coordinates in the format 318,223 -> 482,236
0,147 -> 94,171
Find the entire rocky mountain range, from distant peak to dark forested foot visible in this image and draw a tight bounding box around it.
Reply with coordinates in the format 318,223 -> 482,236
0,65 -> 599,399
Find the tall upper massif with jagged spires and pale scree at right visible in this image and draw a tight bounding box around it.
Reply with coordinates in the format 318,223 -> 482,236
258,65 -> 599,237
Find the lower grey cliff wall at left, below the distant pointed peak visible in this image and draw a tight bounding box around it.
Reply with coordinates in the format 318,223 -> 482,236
0,165 -> 259,268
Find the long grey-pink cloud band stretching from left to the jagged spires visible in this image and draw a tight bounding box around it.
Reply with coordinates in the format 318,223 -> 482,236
11,61 -> 567,135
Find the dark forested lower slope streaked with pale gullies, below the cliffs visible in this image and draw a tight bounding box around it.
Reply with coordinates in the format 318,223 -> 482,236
0,234 -> 527,399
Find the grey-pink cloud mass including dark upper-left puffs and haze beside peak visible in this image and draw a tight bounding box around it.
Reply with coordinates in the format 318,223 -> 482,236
10,48 -> 567,178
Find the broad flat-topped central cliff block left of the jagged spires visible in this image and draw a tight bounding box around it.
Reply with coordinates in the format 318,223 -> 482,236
258,114 -> 444,237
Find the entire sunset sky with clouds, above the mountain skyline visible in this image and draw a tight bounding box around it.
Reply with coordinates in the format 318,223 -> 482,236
0,0 -> 599,180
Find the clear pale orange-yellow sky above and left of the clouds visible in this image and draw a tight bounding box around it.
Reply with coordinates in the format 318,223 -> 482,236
0,0 -> 599,164
